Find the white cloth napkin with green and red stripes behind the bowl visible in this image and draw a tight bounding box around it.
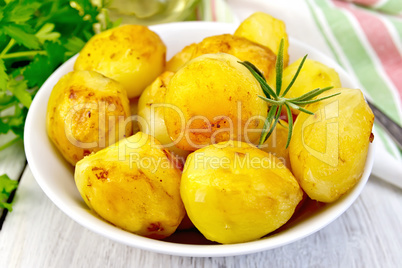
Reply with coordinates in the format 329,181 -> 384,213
189,0 -> 402,183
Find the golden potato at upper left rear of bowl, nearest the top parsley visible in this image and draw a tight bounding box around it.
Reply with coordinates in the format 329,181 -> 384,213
74,25 -> 166,98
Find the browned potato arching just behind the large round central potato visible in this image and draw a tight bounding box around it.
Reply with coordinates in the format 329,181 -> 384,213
167,34 -> 276,78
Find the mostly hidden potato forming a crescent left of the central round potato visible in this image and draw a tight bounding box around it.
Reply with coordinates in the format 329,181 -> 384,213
138,72 -> 190,159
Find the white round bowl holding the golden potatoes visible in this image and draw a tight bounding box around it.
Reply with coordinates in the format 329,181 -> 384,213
25,22 -> 374,257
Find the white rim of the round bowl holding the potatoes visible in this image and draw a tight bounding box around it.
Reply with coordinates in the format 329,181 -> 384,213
24,22 -> 375,257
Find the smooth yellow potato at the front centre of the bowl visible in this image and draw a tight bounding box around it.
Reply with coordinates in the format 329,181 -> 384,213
180,142 -> 303,244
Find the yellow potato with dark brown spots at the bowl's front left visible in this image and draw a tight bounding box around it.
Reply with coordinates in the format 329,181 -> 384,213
74,132 -> 185,239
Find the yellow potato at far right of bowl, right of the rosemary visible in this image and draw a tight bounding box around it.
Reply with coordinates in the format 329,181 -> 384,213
289,88 -> 374,202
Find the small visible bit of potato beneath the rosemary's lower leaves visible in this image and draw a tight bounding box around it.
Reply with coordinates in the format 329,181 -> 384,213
261,120 -> 290,169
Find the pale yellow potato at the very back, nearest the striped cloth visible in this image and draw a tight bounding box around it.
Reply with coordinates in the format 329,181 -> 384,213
234,12 -> 289,66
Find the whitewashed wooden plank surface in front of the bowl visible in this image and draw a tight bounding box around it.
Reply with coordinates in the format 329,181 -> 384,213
0,166 -> 402,268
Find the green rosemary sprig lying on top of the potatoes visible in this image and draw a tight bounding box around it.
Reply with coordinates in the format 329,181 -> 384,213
239,39 -> 341,148
